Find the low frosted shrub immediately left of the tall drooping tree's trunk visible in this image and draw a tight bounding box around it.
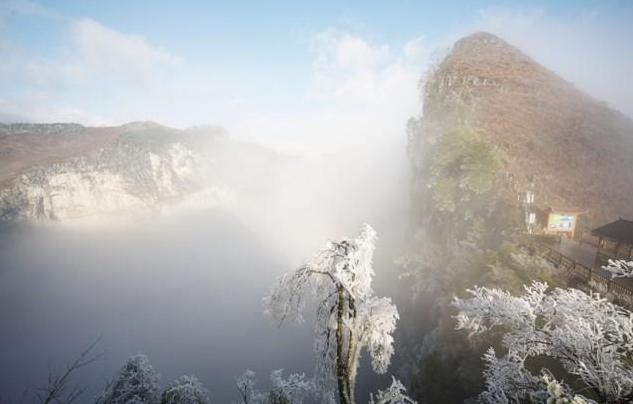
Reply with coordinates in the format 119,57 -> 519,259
236,369 -> 316,404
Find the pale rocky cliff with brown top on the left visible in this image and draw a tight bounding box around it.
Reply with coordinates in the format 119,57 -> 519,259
0,123 -> 232,221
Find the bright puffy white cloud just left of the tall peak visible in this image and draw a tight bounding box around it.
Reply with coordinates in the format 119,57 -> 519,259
311,32 -> 429,146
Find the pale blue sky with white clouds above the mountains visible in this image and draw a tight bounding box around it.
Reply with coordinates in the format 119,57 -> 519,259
0,0 -> 633,149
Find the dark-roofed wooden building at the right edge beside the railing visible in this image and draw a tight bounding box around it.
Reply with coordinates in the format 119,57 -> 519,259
591,218 -> 633,268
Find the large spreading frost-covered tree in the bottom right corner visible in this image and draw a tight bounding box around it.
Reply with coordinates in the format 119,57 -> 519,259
453,282 -> 633,403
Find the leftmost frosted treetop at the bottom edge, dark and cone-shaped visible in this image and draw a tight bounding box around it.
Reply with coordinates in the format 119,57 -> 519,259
97,355 -> 160,404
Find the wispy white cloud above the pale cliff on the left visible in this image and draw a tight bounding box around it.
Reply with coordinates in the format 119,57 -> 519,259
0,19 -> 187,125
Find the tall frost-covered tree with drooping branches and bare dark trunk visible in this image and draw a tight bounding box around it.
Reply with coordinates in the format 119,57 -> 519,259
264,225 -> 398,404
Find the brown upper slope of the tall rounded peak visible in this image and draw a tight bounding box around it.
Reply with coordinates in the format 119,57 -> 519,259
410,33 -> 633,232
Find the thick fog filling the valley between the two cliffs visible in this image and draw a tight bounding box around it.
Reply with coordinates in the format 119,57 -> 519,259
0,138 -> 408,402
